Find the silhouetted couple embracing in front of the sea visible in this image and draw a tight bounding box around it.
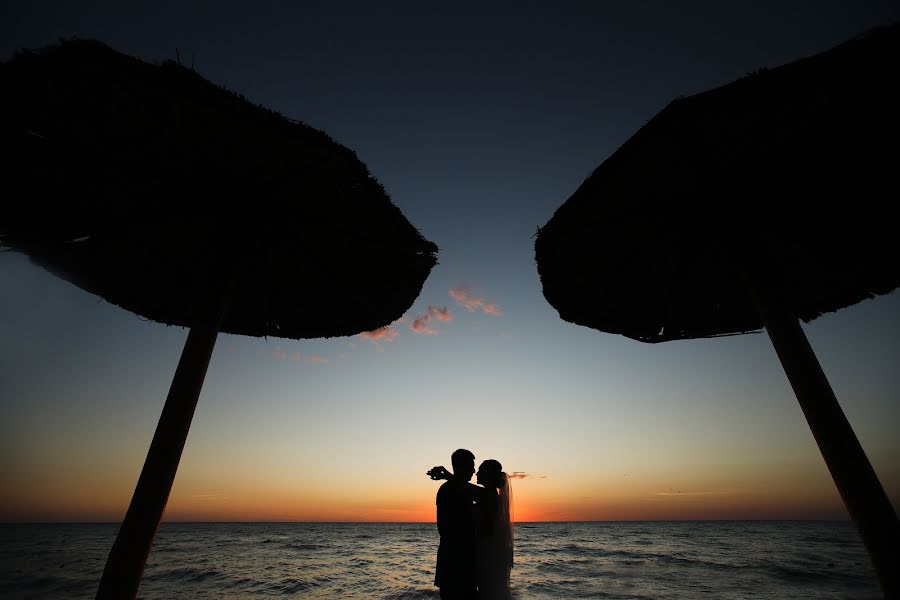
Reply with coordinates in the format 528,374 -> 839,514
428,449 -> 513,600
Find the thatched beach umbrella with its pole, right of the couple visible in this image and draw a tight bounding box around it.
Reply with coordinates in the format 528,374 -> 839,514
535,26 -> 900,597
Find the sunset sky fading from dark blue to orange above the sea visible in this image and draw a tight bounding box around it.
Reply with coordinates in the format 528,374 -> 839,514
0,0 -> 900,521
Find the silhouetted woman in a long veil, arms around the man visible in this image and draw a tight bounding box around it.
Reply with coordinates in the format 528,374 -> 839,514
427,459 -> 513,600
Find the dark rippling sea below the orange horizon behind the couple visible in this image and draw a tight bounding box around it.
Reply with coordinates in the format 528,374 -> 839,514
0,521 -> 881,600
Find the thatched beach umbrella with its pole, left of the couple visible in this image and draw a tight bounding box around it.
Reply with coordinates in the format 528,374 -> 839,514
0,41 -> 437,598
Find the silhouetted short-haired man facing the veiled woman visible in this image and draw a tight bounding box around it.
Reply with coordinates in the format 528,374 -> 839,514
434,448 -> 475,600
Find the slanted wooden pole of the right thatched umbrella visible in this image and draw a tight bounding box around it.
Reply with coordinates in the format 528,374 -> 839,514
748,280 -> 900,600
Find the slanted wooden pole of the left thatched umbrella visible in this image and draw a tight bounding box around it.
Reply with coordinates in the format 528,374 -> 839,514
96,274 -> 231,600
